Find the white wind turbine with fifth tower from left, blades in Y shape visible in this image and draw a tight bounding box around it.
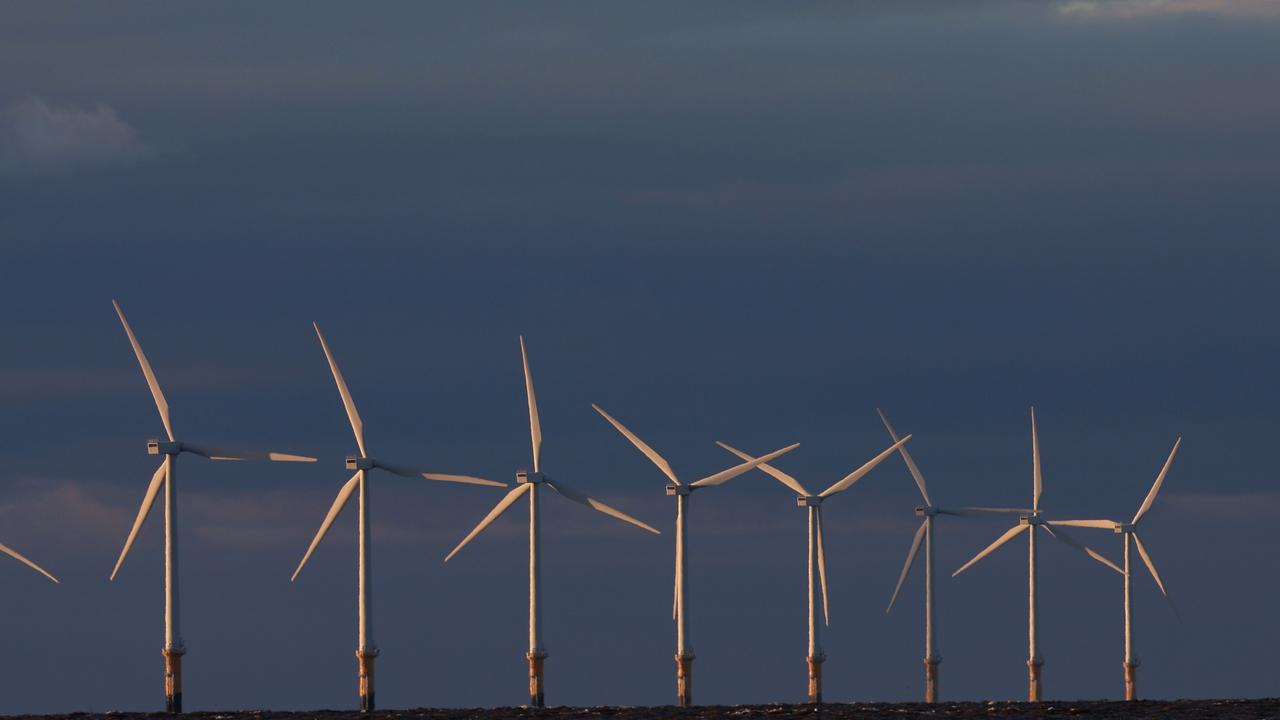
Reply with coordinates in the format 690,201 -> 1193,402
716,436 -> 911,705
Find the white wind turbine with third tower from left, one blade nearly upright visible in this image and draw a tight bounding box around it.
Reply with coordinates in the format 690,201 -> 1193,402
444,336 -> 659,707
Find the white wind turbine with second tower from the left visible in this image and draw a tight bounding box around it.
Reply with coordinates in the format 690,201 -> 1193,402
289,323 -> 507,712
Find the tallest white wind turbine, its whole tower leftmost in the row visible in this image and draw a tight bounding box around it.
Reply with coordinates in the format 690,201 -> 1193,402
111,300 -> 315,712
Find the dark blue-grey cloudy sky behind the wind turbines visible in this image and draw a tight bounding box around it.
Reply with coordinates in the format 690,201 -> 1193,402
0,0 -> 1280,712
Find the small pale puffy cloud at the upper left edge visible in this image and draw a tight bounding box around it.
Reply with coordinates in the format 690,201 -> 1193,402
0,97 -> 147,176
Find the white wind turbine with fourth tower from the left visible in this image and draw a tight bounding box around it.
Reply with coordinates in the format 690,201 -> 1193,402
591,405 -> 800,707
